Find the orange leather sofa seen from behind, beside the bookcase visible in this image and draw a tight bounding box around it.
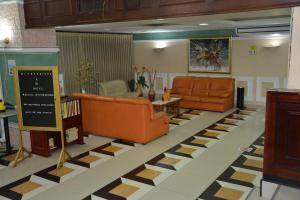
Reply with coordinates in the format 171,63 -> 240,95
73,93 -> 169,143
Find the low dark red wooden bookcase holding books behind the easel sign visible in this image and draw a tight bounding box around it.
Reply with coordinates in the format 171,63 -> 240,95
30,98 -> 84,157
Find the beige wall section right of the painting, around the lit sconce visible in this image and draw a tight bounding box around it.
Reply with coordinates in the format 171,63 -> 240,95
232,38 -> 289,77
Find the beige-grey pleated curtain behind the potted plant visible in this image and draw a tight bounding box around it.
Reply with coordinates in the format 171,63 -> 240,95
56,32 -> 134,94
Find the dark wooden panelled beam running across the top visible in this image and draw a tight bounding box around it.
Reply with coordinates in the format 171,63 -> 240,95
24,0 -> 300,27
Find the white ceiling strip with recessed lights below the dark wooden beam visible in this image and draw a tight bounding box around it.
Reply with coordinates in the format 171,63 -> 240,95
56,9 -> 291,33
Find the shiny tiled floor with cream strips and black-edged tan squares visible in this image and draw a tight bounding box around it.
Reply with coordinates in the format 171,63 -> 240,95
0,109 -> 264,199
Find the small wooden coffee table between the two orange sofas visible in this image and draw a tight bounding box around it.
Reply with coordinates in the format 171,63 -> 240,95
152,97 -> 181,114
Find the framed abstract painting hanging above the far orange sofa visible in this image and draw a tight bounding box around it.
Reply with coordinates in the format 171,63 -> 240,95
188,38 -> 231,74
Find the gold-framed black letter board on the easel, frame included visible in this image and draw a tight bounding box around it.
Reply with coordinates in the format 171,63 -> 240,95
14,66 -> 62,131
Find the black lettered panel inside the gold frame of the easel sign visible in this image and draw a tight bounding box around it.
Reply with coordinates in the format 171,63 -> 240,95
18,70 -> 56,127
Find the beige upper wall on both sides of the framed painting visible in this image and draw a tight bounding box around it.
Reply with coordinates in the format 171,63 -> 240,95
134,38 -> 289,103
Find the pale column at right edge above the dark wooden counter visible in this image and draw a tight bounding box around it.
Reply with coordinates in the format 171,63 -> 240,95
288,7 -> 300,89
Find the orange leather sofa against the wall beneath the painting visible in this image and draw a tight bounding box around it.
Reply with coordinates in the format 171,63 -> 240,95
171,76 -> 235,112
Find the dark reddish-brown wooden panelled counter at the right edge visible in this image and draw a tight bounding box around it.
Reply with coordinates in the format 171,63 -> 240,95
263,90 -> 300,186
